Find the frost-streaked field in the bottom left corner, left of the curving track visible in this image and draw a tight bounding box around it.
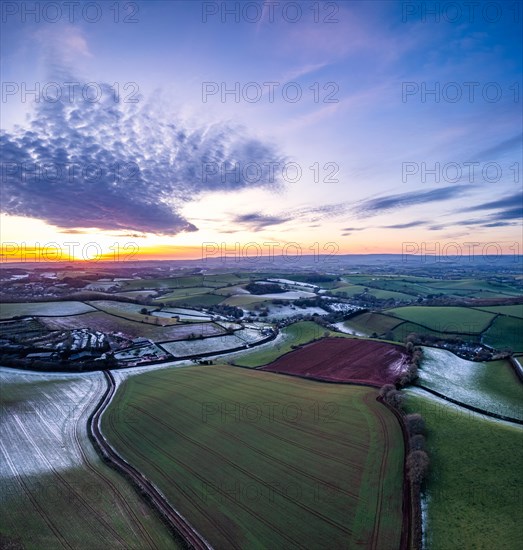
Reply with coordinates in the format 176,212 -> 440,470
0,368 -> 175,549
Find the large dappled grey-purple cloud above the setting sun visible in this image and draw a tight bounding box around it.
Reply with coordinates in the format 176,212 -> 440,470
0,74 -> 285,235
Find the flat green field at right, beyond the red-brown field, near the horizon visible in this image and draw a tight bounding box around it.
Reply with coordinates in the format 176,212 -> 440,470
385,306 -> 495,334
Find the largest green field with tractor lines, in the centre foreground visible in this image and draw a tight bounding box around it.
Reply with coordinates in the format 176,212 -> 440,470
102,366 -> 403,549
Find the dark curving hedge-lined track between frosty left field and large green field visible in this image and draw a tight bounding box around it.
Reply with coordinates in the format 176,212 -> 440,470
87,371 -> 213,550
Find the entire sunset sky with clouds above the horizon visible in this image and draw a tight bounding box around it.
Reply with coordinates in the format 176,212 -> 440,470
0,0 -> 523,261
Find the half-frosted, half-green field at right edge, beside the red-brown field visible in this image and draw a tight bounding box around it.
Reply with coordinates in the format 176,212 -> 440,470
418,347 -> 523,420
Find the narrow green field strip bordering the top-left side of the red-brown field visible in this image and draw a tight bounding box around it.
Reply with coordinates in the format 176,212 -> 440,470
234,321 -> 332,367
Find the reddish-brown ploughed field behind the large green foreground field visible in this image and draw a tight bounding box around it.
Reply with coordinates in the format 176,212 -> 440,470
260,338 -> 407,386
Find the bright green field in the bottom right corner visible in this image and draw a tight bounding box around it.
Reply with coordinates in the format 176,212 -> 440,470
406,390 -> 523,550
